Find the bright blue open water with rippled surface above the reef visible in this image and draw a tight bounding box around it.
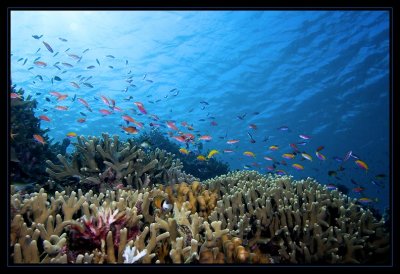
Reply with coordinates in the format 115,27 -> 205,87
11,11 -> 390,214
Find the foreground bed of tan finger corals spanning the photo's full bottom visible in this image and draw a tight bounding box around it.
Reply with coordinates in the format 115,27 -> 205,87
10,171 -> 390,264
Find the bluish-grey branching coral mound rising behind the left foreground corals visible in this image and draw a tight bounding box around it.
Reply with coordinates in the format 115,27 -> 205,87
46,133 -> 197,192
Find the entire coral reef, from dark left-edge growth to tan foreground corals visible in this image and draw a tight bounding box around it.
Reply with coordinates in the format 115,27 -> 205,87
9,90 -> 390,265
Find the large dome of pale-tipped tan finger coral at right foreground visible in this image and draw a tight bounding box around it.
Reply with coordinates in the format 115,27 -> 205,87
205,172 -> 389,263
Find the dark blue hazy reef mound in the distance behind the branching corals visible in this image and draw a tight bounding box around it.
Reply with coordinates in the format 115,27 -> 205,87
135,129 -> 229,180
